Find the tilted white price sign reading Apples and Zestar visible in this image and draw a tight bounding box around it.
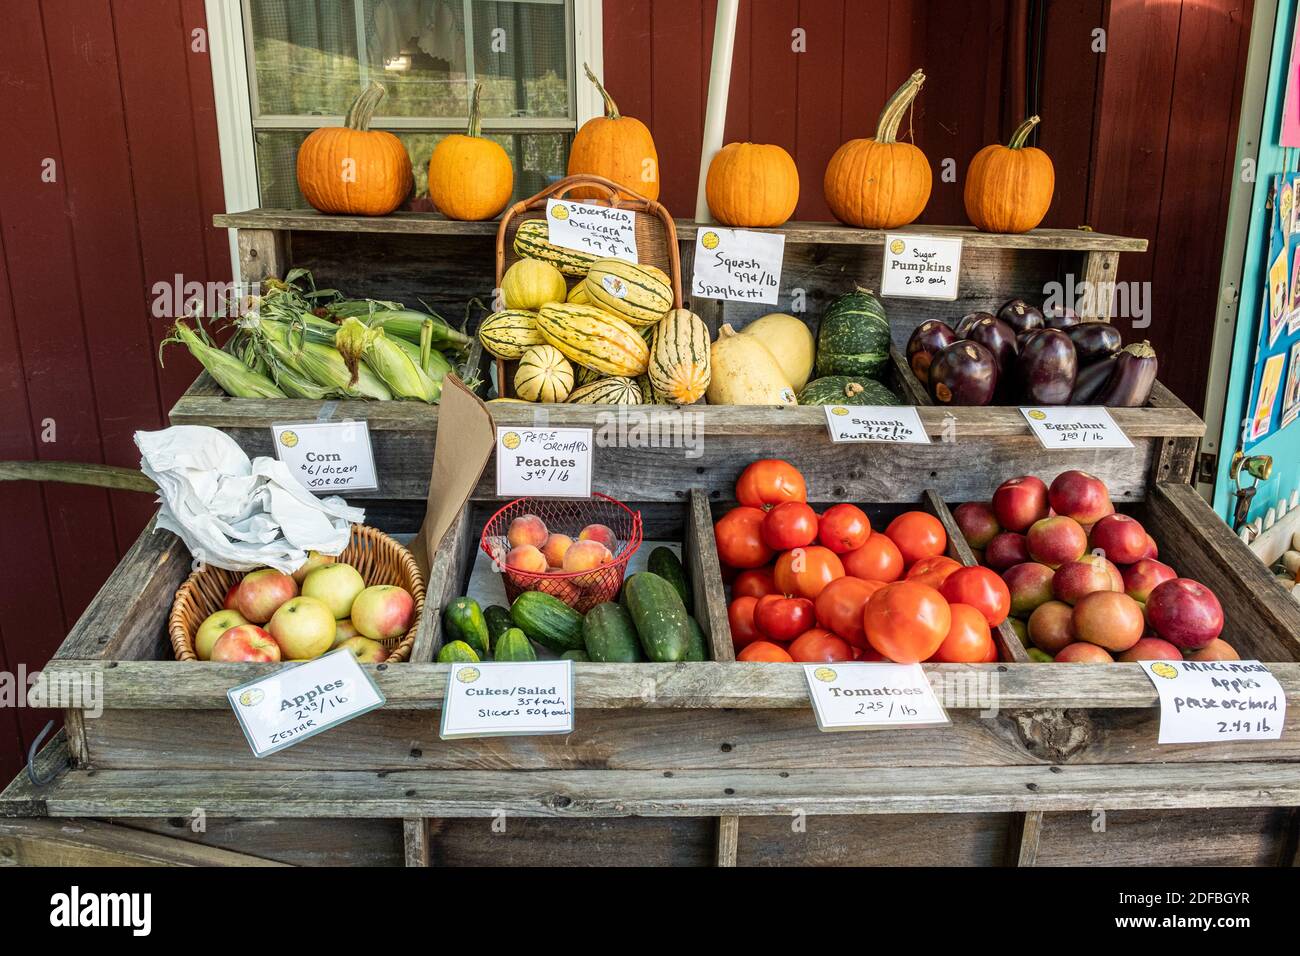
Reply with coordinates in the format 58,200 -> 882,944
226,649 -> 384,757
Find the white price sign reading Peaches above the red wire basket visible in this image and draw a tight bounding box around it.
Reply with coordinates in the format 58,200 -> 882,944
497,425 -> 593,498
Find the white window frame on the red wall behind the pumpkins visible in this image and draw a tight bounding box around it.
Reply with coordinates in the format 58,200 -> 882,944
204,0 -> 605,281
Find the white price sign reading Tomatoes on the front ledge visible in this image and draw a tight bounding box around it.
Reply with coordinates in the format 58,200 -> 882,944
803,663 -> 949,731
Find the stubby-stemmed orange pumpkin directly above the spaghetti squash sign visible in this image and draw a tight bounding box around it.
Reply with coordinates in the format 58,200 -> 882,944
705,143 -> 800,226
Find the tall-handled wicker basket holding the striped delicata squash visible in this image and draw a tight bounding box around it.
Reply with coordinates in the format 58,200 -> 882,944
497,176 -> 681,398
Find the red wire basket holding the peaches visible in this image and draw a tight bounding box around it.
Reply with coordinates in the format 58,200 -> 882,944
482,492 -> 641,611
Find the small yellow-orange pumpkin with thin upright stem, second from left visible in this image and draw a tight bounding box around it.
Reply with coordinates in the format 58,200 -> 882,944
429,83 -> 515,221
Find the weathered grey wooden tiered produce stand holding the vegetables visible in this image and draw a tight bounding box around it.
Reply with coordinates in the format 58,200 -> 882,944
0,211 -> 1300,866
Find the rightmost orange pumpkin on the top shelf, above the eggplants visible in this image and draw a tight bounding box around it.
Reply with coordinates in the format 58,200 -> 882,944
962,116 -> 1056,233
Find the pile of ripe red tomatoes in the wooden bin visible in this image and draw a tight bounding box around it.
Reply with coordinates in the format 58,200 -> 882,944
714,459 -> 1011,663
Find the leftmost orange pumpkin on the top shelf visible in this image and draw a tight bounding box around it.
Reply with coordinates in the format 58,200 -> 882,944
298,83 -> 412,216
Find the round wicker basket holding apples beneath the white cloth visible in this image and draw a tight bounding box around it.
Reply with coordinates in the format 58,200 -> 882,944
168,524 -> 424,663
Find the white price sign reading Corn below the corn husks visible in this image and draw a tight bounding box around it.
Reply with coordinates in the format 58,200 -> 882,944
270,421 -> 380,494
